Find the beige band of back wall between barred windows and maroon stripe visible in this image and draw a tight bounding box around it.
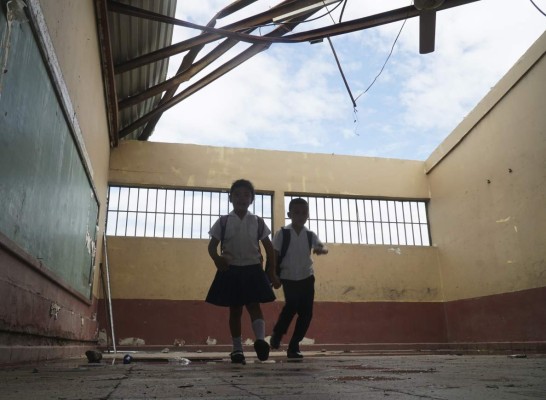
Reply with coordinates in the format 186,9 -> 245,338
108,237 -> 442,302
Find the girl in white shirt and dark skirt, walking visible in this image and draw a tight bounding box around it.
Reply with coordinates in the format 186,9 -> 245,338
206,179 -> 280,364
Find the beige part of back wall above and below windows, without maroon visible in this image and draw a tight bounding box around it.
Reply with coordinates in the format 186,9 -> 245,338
108,141 -> 442,302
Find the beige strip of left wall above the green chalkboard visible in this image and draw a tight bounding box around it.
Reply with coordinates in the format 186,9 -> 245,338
40,0 -> 110,295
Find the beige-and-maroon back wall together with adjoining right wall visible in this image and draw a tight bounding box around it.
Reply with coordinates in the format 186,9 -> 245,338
101,35 -> 546,348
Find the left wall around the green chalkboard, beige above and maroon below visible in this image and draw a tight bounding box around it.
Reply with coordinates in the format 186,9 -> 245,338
0,0 -> 110,363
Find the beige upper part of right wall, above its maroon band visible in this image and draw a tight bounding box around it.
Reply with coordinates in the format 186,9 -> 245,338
426,34 -> 546,301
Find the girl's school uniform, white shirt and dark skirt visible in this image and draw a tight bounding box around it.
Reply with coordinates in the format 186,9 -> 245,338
206,211 -> 275,307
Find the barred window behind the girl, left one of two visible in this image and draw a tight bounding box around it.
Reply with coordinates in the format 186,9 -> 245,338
106,186 -> 272,239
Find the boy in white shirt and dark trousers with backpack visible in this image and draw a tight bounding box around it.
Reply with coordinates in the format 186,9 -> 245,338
269,198 -> 328,359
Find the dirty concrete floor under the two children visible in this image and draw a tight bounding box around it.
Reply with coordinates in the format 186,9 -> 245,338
0,350 -> 546,400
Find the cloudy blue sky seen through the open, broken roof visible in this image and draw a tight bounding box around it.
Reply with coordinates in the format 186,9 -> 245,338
149,0 -> 546,160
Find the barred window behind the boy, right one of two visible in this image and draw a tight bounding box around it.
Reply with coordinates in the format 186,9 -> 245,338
284,195 -> 430,246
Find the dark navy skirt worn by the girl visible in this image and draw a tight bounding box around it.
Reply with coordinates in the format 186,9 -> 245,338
206,264 -> 275,307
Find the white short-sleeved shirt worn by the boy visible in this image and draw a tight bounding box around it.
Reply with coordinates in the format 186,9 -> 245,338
273,224 -> 321,281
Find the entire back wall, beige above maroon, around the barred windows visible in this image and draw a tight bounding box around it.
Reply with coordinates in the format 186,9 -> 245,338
108,145 -> 445,345
